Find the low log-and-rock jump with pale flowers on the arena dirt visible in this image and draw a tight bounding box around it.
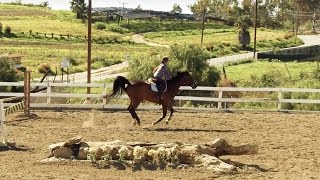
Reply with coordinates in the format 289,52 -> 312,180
48,137 -> 258,172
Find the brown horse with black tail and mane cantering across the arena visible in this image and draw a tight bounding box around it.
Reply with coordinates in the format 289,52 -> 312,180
105,72 -> 197,125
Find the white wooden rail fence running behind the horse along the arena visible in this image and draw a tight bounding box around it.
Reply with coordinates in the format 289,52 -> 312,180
0,82 -> 320,111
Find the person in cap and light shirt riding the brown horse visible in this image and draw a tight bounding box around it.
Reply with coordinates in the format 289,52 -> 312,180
153,56 -> 172,101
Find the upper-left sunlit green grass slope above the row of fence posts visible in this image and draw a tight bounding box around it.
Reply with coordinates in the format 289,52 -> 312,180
0,4 -> 124,37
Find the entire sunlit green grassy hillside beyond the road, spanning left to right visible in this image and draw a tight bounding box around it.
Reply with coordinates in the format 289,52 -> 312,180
0,4 -> 301,80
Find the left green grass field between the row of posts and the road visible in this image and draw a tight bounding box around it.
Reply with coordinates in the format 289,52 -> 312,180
0,40 -> 161,76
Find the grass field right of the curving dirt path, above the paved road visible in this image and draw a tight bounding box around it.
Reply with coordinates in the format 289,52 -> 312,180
145,27 -> 302,50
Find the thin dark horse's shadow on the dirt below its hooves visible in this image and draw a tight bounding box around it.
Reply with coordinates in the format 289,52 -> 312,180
143,127 -> 236,132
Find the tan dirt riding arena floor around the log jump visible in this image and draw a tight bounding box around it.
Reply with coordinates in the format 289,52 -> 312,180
0,110 -> 320,180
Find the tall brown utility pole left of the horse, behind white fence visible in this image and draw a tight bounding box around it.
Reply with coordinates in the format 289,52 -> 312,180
87,0 -> 92,97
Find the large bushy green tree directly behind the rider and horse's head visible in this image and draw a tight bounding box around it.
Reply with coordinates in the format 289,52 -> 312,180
128,45 -> 220,86
